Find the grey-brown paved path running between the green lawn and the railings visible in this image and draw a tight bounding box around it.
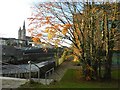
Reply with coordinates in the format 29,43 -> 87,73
49,61 -> 81,81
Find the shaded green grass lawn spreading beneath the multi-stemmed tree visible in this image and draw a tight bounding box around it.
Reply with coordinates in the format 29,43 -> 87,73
21,69 -> 120,88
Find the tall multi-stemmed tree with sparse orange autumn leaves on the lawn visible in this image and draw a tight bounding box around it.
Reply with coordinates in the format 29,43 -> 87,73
29,2 -> 119,80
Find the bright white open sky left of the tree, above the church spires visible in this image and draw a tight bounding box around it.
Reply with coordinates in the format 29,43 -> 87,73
0,0 -> 35,38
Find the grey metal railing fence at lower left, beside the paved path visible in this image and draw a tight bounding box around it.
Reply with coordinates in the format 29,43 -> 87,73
1,61 -> 54,84
